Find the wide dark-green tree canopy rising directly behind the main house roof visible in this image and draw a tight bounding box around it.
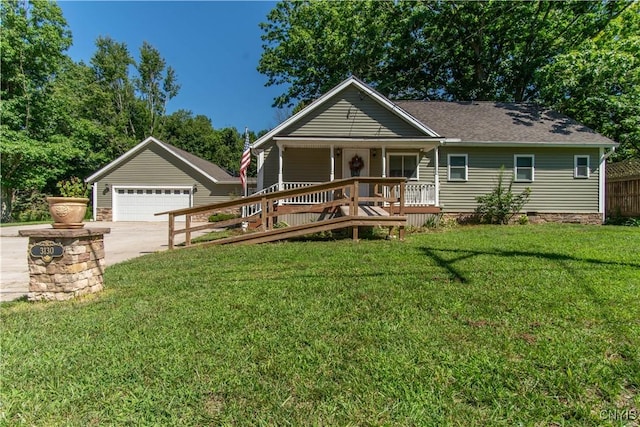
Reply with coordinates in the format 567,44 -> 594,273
258,0 -> 629,107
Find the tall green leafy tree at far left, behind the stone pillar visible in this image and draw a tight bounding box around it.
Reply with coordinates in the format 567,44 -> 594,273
0,1 -> 75,220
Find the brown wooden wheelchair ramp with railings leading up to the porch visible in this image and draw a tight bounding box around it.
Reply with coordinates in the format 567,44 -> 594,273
156,177 -> 407,249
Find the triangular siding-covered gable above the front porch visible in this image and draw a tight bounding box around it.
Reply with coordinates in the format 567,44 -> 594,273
280,87 -> 424,137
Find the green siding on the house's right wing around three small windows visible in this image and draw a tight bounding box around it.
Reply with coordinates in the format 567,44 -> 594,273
439,147 -> 599,213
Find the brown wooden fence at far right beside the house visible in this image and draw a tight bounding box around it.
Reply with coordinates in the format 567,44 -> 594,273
606,158 -> 640,217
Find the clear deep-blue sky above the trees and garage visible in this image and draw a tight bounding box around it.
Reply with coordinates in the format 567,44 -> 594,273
58,1 -> 284,133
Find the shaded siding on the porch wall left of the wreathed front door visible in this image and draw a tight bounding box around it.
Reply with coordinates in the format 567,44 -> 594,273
282,147 -> 331,182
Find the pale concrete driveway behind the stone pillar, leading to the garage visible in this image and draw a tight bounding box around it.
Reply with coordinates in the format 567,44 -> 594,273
0,221 -> 205,301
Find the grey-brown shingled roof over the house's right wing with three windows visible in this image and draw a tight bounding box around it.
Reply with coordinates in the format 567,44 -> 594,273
395,101 -> 616,146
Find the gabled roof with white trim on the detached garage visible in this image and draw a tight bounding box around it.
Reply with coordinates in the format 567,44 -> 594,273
85,136 -> 239,183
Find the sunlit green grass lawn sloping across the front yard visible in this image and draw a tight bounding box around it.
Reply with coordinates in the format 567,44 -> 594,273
0,225 -> 640,426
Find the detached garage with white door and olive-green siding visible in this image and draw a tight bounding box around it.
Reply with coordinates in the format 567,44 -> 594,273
85,137 -> 248,221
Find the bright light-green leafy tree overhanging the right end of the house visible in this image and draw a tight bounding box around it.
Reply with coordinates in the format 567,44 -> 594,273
538,2 -> 640,159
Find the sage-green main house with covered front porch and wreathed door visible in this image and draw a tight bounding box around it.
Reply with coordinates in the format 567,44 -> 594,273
252,77 -> 616,225
